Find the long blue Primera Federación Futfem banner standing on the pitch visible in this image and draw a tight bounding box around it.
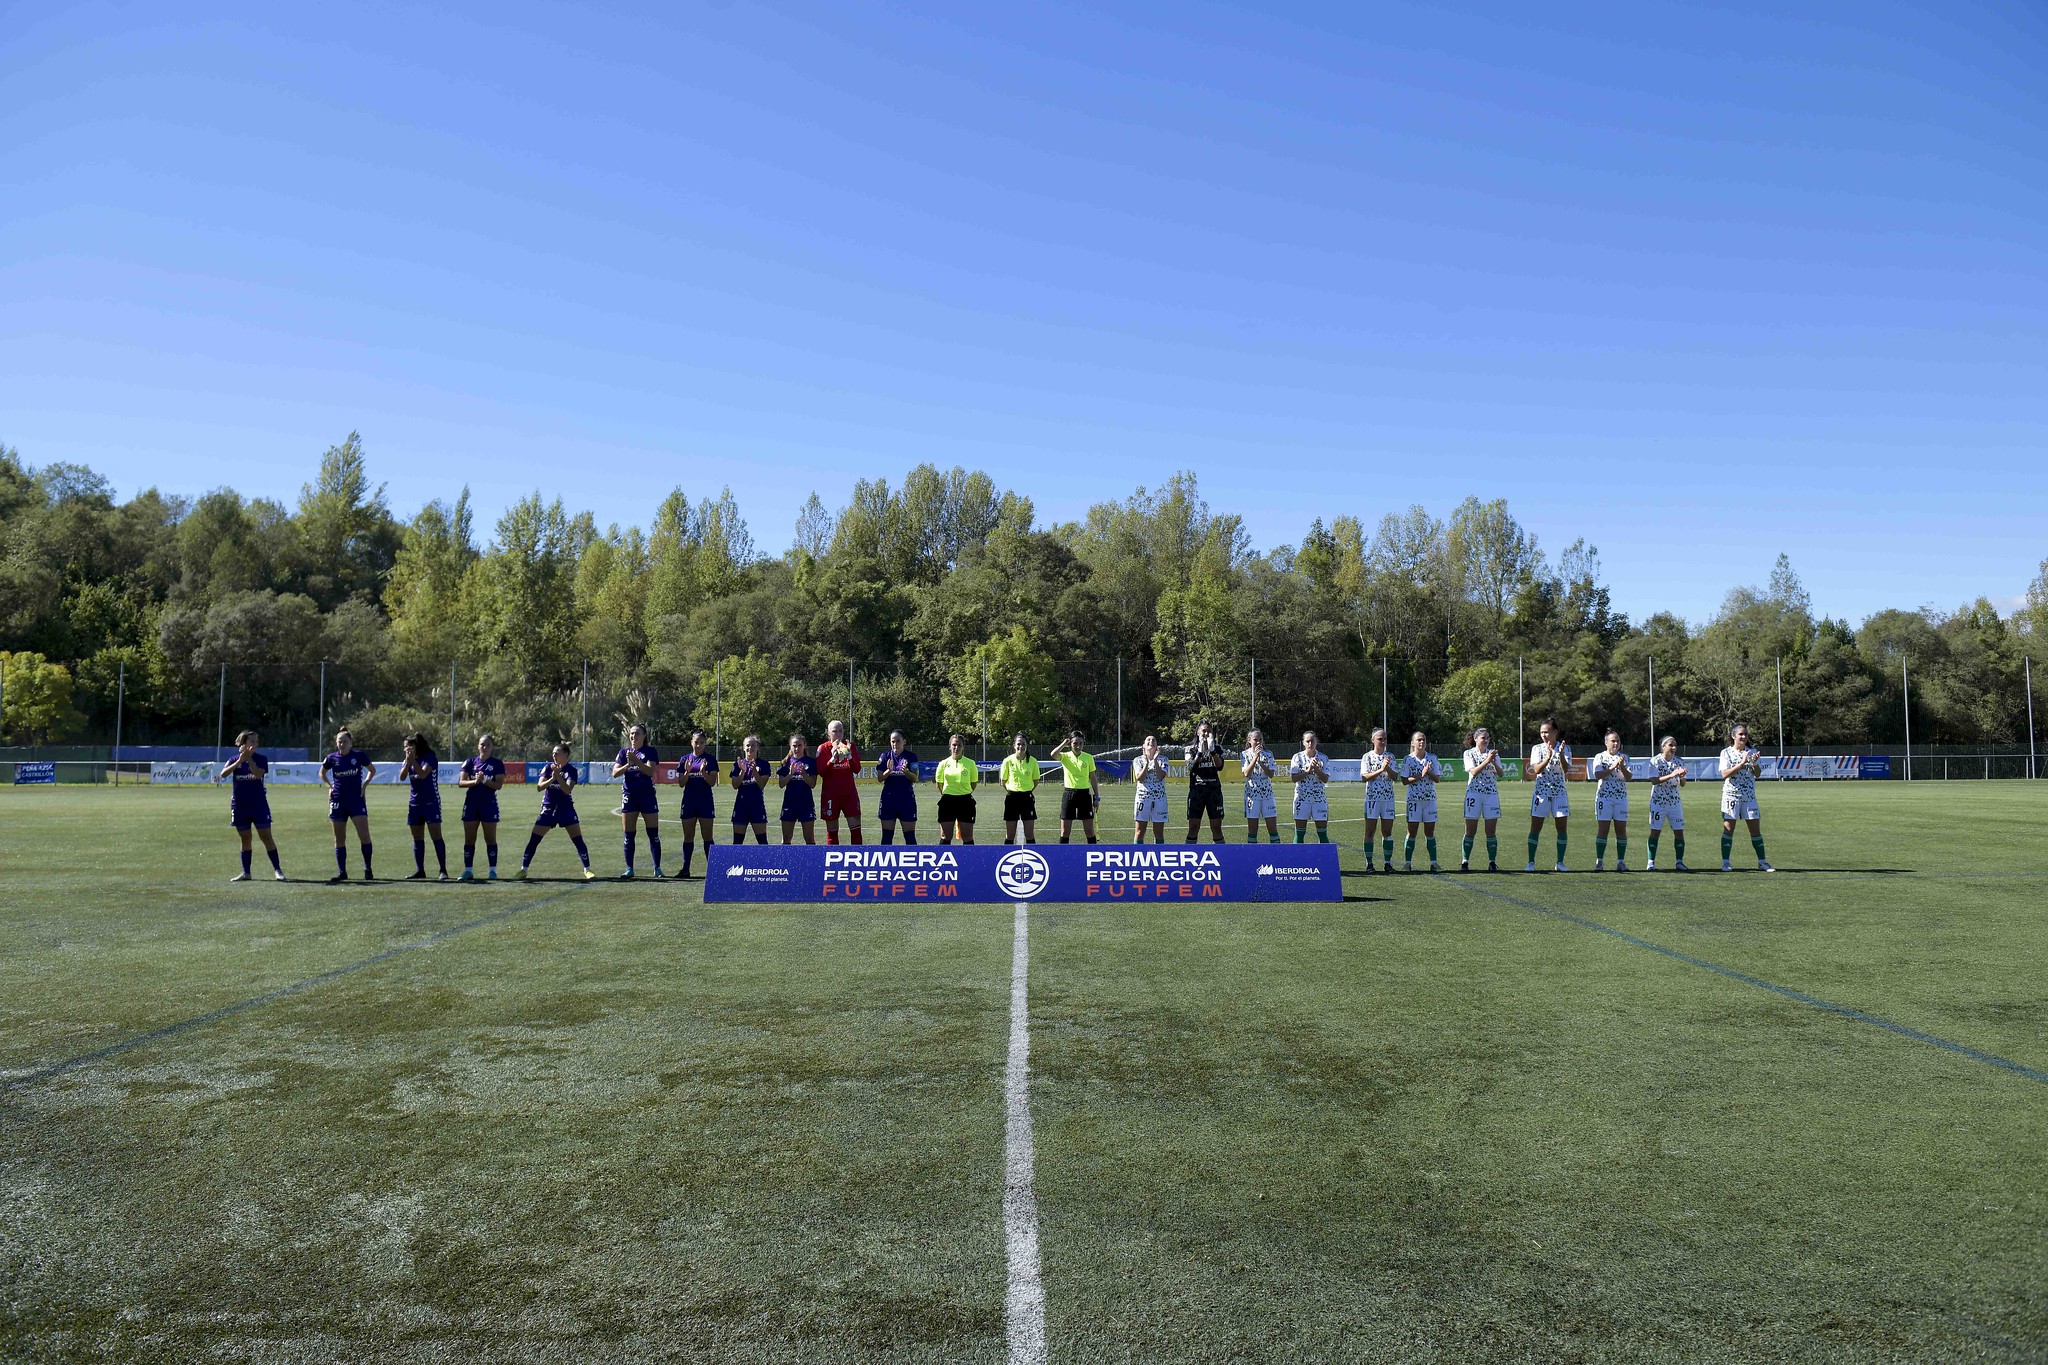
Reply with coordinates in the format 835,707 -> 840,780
705,843 -> 1343,905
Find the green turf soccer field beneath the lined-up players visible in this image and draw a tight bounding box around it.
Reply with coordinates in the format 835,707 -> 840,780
0,782 -> 2048,1361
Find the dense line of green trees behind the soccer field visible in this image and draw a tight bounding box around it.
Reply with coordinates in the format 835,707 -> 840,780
0,434 -> 2048,751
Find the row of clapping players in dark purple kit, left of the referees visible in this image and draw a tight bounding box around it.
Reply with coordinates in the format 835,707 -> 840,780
215,724 -> 918,884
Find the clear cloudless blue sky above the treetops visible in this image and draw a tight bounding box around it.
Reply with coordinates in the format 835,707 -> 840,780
0,0 -> 2048,618
